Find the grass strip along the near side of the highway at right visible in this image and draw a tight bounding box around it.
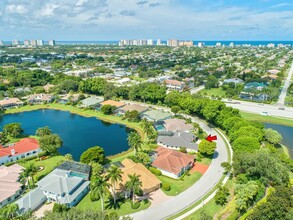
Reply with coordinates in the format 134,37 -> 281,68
240,112 -> 293,127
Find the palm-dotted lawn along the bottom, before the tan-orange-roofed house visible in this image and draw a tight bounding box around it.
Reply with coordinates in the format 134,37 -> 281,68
76,193 -> 151,216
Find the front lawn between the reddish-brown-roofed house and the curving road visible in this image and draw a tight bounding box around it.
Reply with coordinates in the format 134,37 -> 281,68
158,172 -> 202,196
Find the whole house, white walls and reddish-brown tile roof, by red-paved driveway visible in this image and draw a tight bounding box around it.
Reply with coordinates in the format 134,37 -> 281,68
152,147 -> 194,179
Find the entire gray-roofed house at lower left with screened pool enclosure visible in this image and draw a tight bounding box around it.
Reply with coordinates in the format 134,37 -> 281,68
16,162 -> 90,212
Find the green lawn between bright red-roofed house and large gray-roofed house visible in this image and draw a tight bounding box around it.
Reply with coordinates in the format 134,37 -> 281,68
19,156 -> 64,181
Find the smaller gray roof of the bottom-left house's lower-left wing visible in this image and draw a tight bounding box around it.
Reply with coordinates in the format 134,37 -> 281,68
15,187 -> 47,212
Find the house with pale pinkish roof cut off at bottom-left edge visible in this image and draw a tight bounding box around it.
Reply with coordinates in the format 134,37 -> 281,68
0,164 -> 24,208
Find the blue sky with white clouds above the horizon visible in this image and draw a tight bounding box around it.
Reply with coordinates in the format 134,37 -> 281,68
0,0 -> 293,41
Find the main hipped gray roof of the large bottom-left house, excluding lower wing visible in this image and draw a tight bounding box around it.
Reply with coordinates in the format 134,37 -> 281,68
38,169 -> 83,195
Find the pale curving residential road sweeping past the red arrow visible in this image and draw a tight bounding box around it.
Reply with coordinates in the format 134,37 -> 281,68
130,102 -> 228,220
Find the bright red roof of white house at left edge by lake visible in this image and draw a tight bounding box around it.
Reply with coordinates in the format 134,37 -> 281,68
0,138 -> 40,157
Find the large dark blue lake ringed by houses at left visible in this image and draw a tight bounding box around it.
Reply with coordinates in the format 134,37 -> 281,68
0,109 -> 131,161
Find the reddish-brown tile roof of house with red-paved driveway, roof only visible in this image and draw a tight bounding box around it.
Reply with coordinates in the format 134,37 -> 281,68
152,147 -> 194,175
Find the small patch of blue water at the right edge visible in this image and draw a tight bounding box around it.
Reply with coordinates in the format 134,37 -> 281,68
264,123 -> 293,158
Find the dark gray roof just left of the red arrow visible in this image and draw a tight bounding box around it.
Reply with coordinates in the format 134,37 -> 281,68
157,132 -> 198,150
